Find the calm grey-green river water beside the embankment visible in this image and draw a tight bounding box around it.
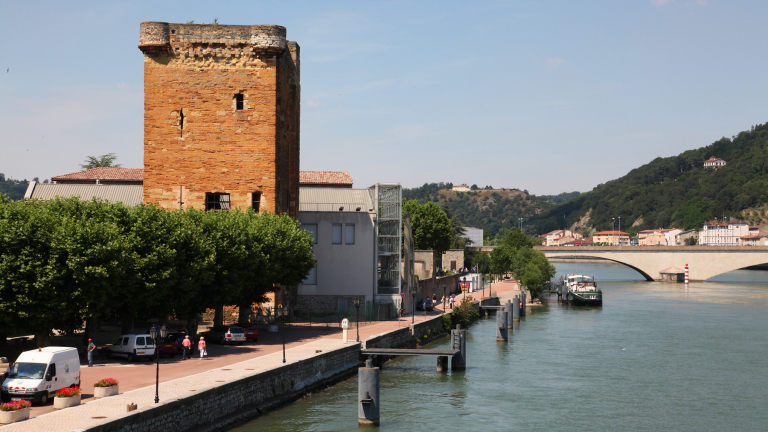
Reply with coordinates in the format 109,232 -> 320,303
234,264 -> 768,432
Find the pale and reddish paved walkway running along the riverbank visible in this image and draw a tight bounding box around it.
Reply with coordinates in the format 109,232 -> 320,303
0,280 -> 520,432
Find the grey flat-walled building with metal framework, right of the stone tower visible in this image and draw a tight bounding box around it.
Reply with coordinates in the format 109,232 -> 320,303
296,183 -> 402,314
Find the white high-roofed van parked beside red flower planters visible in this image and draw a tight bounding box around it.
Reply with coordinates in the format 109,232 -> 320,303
0,347 -> 80,405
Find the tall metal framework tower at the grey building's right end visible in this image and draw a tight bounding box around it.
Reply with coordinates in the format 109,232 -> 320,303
368,183 -> 403,297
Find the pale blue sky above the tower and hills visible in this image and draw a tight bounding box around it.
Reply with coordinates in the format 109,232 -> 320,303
0,0 -> 768,194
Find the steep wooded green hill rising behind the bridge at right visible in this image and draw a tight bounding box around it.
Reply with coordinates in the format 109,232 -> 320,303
527,123 -> 768,235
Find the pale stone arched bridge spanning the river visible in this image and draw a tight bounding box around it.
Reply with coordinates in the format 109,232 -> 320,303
470,246 -> 768,281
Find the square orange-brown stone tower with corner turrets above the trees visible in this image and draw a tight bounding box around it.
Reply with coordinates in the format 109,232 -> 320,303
139,22 -> 301,217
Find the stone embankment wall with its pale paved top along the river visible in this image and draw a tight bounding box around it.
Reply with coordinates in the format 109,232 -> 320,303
0,315 -> 450,432
